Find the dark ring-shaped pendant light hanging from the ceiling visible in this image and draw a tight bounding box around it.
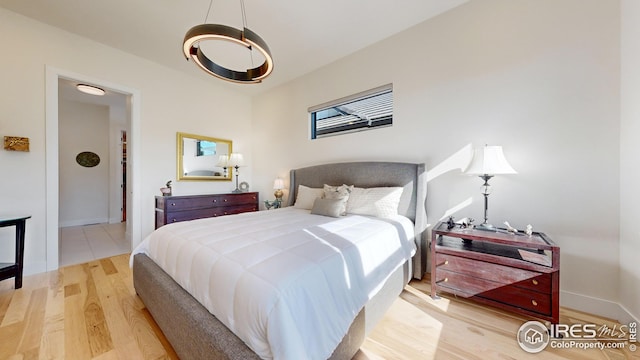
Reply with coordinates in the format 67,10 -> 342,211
182,0 -> 273,84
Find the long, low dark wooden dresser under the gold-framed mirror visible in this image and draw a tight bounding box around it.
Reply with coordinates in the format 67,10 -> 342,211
156,192 -> 258,229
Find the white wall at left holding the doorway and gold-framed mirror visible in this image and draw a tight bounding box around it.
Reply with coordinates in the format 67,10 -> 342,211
0,9 -> 252,273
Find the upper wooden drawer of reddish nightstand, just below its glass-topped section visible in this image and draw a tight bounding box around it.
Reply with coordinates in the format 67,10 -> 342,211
436,253 -> 551,294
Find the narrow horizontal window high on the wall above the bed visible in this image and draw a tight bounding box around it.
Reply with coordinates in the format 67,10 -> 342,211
309,84 -> 393,139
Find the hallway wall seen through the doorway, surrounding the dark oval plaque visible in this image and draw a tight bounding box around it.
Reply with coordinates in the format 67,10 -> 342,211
58,100 -> 112,227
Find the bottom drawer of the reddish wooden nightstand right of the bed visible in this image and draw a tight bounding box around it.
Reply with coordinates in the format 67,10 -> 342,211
436,270 -> 551,315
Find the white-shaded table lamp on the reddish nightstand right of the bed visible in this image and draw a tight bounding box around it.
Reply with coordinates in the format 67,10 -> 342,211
464,145 -> 517,231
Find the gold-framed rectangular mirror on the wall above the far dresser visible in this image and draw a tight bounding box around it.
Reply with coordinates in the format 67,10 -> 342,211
176,132 -> 232,181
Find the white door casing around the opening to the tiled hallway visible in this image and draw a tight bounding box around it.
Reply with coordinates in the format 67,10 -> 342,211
46,66 -> 141,270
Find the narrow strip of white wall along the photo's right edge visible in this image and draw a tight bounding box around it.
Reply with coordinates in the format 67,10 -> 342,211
620,0 -> 640,319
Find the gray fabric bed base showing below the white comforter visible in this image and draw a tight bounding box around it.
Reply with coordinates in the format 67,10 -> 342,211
133,254 -> 412,360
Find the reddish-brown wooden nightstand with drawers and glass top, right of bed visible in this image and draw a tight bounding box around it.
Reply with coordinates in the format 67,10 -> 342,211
431,222 -> 560,324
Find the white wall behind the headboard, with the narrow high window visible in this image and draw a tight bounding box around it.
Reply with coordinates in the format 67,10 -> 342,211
253,0 -> 620,316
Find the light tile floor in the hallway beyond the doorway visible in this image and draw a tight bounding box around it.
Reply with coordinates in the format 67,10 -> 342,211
59,223 -> 131,267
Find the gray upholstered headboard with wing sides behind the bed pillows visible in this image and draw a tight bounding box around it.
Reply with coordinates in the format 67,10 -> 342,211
287,162 -> 427,279
